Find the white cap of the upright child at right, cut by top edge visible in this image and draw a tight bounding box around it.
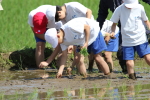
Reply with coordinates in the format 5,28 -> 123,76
123,0 -> 139,8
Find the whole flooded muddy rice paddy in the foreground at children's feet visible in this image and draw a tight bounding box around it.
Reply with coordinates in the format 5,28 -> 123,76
0,68 -> 150,100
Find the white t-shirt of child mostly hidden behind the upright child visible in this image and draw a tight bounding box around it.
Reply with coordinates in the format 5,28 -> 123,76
101,20 -> 119,36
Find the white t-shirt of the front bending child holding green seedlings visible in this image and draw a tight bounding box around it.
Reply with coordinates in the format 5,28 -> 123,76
61,17 -> 100,51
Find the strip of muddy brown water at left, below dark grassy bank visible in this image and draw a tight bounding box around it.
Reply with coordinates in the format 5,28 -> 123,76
0,69 -> 56,80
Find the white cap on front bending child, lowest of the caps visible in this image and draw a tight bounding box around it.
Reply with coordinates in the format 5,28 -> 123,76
45,28 -> 58,48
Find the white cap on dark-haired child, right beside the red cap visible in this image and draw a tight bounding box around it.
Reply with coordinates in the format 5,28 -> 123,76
46,6 -> 56,25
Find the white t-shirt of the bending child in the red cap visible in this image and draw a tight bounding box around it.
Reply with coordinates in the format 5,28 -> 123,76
28,5 -> 62,29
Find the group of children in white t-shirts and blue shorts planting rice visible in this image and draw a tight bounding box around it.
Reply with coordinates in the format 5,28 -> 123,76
28,0 -> 150,79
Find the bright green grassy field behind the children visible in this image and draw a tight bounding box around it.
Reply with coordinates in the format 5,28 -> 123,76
0,0 -> 150,52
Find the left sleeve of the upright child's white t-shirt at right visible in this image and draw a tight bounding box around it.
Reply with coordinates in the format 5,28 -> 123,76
110,7 -> 121,23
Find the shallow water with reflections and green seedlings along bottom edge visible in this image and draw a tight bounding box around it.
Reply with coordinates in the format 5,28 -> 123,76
4,84 -> 150,100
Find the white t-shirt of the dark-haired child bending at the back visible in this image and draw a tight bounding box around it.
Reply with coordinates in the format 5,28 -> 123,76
61,2 -> 94,24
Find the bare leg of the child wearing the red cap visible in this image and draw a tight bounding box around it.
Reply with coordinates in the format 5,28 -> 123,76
35,42 -> 45,67
